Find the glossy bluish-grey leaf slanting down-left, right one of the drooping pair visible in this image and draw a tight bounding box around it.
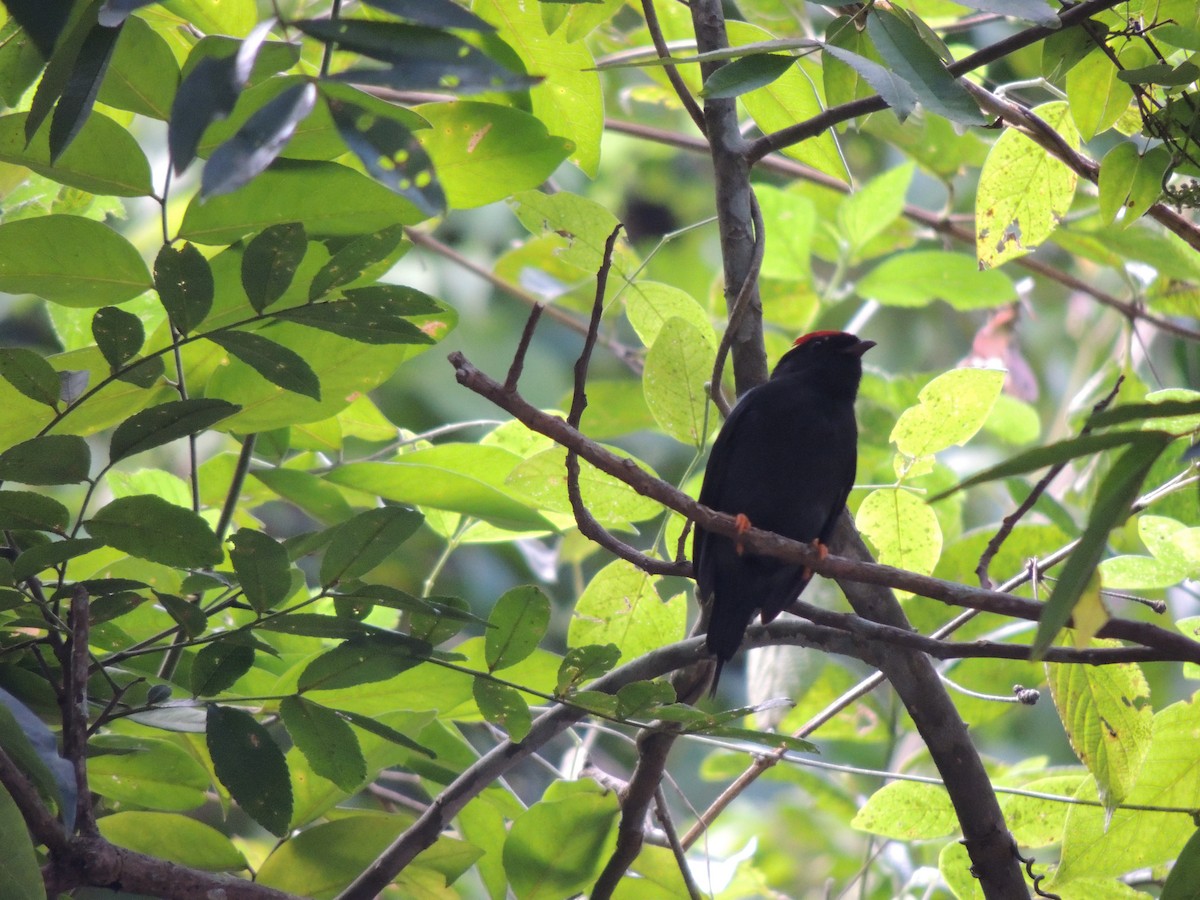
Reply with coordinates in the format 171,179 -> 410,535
200,82 -> 317,198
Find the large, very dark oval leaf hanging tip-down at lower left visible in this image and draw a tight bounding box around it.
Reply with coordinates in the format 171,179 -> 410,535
204,704 -> 292,838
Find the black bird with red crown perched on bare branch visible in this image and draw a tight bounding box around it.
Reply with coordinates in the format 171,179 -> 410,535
692,331 -> 875,690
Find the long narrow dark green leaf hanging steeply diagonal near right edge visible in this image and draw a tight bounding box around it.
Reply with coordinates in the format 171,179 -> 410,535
1031,431 -> 1172,659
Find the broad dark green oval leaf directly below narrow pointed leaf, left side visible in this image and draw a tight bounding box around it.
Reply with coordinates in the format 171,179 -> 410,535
86,494 -> 223,569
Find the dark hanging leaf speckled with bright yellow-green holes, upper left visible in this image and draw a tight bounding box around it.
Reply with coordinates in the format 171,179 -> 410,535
322,82 -> 446,216
